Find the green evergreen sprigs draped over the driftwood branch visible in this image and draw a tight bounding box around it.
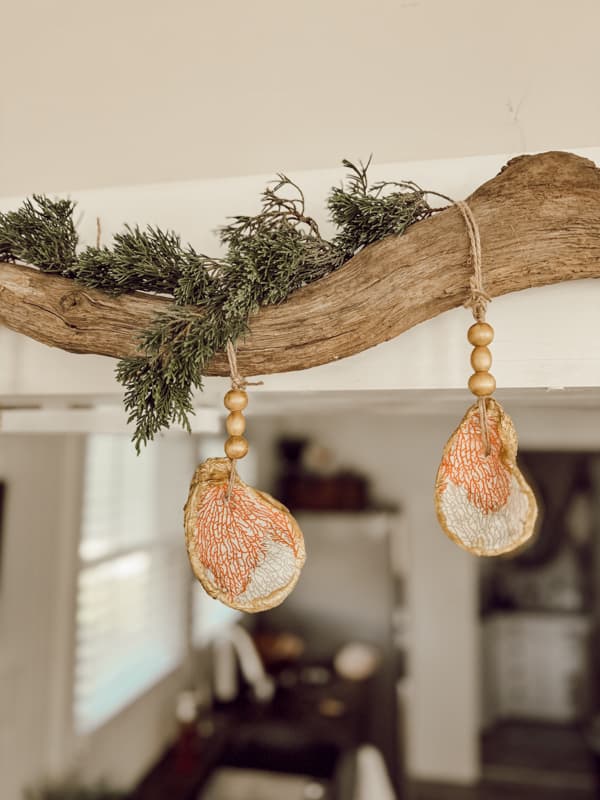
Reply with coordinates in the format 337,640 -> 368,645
0,161 -> 433,452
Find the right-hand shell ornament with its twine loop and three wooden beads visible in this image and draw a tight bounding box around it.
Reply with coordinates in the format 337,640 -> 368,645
435,201 -> 537,556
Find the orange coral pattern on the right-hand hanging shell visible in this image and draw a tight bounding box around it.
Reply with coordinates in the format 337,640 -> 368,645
440,410 -> 511,514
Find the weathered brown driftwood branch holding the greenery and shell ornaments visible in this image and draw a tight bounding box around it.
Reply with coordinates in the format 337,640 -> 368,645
0,152 -> 600,375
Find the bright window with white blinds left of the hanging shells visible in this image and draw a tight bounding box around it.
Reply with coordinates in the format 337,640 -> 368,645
73,435 -> 186,733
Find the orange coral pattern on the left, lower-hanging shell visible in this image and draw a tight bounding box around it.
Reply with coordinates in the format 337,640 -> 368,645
196,481 -> 298,599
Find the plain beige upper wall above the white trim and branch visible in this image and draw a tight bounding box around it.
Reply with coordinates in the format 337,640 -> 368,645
0,0 -> 600,195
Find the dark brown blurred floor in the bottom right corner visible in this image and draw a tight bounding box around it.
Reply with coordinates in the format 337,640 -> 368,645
406,722 -> 600,800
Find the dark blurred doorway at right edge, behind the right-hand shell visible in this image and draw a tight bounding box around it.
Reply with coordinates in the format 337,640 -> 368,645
480,451 -> 600,797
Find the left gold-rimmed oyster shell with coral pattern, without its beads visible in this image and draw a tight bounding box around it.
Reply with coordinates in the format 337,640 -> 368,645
184,458 -> 306,612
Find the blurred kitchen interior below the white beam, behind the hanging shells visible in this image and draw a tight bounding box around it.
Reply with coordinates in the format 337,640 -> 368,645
0,401 -> 600,800
